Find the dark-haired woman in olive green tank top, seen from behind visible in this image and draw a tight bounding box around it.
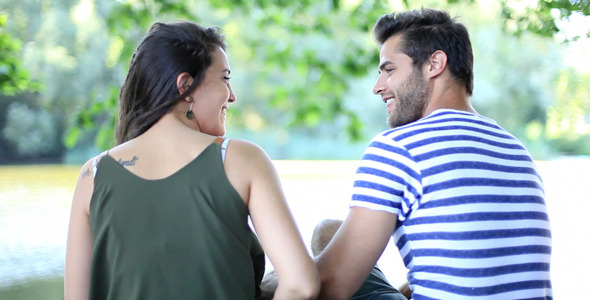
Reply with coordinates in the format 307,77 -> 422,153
65,22 -> 319,300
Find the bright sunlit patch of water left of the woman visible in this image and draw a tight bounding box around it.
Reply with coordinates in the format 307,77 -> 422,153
0,166 -> 79,288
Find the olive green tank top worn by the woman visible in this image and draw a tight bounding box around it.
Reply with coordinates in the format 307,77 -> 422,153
89,139 -> 264,300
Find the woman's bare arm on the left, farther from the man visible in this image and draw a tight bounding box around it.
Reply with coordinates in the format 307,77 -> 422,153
64,161 -> 94,300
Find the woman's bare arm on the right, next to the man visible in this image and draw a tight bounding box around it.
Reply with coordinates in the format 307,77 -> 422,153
226,140 -> 320,299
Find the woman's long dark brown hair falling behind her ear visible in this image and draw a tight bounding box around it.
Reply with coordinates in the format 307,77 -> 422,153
115,21 -> 225,145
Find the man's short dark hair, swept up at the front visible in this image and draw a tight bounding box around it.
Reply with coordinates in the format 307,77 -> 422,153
373,8 -> 473,95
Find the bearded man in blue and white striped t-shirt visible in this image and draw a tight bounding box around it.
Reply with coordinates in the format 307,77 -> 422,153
316,9 -> 552,300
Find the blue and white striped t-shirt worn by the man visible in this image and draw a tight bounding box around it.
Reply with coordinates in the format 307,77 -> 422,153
351,109 -> 552,300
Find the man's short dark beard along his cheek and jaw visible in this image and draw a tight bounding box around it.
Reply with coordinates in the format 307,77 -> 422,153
387,68 -> 430,128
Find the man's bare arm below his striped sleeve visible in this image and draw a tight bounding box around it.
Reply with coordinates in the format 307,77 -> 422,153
315,207 -> 397,299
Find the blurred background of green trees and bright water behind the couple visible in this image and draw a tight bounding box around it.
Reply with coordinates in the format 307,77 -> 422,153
0,0 -> 590,300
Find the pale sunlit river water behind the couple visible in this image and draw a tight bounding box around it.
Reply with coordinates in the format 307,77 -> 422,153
0,158 -> 590,300
